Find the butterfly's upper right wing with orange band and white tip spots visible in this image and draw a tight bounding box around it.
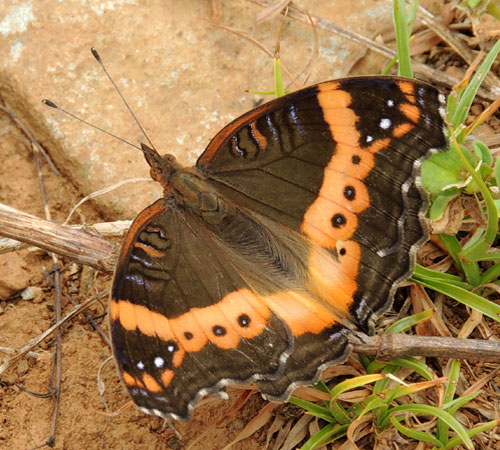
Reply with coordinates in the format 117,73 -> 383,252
196,77 -> 446,330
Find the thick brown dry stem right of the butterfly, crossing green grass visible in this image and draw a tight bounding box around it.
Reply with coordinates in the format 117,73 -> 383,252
351,333 -> 500,363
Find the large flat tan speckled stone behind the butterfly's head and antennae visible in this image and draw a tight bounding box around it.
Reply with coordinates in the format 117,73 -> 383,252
0,0 -> 391,219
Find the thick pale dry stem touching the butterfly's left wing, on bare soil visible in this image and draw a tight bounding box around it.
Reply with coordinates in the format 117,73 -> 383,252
0,205 -> 117,273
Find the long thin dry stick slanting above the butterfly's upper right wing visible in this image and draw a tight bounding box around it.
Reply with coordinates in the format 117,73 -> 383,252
249,0 -> 500,101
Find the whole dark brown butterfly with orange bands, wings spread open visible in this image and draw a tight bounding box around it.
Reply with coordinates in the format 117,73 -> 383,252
109,76 -> 446,420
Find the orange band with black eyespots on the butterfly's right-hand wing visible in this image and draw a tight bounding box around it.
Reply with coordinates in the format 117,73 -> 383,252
301,85 -> 400,317
